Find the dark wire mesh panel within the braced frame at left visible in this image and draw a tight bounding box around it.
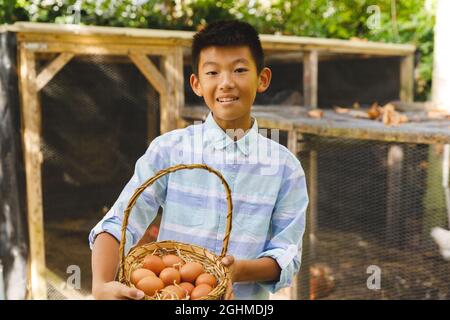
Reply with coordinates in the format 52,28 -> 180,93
37,55 -> 159,298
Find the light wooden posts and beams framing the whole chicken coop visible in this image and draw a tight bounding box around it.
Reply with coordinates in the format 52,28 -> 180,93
10,22 -> 415,299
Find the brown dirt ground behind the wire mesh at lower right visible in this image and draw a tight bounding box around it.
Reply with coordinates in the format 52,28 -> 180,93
314,230 -> 450,300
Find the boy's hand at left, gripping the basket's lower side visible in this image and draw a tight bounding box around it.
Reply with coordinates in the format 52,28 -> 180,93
92,281 -> 144,300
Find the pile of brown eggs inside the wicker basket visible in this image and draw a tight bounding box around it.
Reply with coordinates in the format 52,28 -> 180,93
130,254 -> 217,300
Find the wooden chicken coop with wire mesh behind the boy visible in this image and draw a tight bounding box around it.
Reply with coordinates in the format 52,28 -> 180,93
0,23 -> 450,299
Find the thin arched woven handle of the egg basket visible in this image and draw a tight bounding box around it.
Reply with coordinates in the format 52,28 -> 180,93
119,164 -> 233,279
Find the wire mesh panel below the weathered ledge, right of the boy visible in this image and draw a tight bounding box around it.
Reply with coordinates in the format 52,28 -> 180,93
299,136 -> 450,299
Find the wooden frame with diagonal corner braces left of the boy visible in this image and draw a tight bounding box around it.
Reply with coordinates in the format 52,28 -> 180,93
17,26 -> 184,299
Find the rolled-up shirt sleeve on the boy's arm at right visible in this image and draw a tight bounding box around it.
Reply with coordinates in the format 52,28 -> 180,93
258,159 -> 309,293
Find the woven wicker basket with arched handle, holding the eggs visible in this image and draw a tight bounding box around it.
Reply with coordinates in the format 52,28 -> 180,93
119,164 -> 233,300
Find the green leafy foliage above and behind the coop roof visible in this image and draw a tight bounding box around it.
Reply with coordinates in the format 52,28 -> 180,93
0,0 -> 435,100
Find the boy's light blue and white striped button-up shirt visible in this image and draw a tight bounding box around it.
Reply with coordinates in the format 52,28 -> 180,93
89,113 -> 308,299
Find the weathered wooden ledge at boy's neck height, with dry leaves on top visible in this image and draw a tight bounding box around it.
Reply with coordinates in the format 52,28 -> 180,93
182,105 -> 450,144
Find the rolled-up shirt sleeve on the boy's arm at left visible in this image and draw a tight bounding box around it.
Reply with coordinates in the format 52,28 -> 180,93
89,137 -> 169,254
